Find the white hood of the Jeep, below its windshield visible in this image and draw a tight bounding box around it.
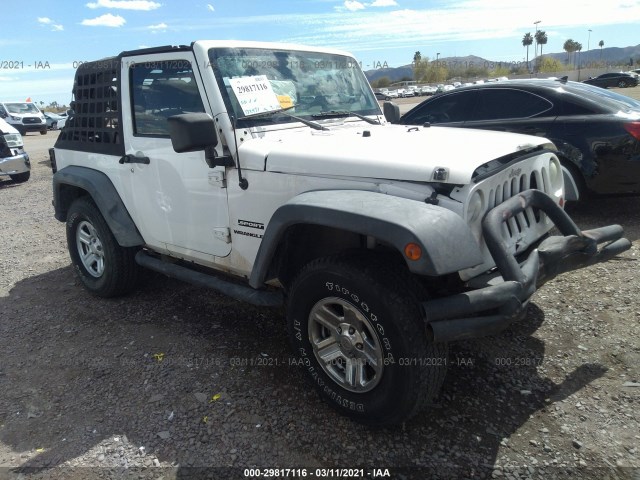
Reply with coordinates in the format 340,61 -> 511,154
240,124 -> 549,184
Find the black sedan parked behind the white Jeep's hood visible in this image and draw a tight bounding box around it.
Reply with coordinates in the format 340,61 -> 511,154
398,79 -> 640,200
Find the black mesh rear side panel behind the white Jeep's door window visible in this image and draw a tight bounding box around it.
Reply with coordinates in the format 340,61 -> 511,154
55,57 -> 124,155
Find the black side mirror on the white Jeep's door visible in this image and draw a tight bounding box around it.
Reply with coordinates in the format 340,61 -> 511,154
167,113 -> 218,153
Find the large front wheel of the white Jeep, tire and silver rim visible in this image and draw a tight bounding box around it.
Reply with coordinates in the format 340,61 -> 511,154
287,254 -> 447,425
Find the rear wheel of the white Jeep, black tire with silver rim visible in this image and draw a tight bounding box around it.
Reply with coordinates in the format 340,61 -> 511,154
66,197 -> 140,298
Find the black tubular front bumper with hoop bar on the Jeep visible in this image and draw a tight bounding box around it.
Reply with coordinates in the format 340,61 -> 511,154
422,190 -> 631,342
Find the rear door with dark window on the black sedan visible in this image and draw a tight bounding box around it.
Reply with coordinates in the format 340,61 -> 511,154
465,88 -> 557,137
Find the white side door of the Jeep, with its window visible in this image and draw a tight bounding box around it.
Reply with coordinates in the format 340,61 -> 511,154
121,51 -> 231,261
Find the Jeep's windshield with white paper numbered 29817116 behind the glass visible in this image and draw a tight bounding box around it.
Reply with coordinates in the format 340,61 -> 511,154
209,48 -> 380,127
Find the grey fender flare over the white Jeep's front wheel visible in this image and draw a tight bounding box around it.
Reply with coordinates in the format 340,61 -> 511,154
249,190 -> 483,288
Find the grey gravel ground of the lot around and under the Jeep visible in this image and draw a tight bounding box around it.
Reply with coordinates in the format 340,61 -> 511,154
0,102 -> 640,479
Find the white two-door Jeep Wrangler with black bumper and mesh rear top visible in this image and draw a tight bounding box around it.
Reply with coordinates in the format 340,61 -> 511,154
51,41 -> 630,425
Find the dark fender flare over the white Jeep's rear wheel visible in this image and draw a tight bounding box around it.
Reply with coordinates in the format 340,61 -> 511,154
53,165 -> 144,247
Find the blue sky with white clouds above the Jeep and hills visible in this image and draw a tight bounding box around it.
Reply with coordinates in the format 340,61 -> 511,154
0,0 -> 640,104
